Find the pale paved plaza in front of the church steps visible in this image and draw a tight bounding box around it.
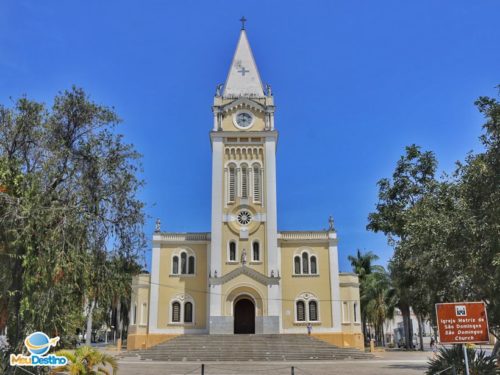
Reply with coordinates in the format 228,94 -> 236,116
119,352 -> 431,375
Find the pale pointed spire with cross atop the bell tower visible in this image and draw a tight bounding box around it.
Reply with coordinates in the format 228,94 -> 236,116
223,17 -> 264,97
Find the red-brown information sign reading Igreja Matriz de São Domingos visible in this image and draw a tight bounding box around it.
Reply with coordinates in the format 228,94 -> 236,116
436,302 -> 489,344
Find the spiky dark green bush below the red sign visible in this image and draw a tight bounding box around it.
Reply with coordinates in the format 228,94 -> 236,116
426,345 -> 500,375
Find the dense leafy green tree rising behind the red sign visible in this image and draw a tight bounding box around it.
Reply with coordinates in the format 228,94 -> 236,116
367,86 -> 500,349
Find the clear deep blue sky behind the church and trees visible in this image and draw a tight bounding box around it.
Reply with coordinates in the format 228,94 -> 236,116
0,0 -> 500,271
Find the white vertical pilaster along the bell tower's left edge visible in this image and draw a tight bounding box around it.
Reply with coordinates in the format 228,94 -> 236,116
210,137 -> 223,316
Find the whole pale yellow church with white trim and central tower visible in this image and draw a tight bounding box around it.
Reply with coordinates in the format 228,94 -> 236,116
127,28 -> 363,349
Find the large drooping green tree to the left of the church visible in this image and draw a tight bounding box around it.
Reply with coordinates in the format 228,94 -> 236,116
0,87 -> 144,356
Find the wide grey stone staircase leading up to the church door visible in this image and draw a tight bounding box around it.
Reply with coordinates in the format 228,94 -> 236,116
127,334 -> 373,362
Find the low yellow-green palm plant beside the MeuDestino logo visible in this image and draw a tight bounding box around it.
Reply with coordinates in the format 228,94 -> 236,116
50,346 -> 118,375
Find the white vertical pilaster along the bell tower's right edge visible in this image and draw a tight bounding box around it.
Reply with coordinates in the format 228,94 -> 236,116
264,137 -> 281,316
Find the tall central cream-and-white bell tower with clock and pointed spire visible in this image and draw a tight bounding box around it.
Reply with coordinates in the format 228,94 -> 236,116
208,22 -> 281,333
